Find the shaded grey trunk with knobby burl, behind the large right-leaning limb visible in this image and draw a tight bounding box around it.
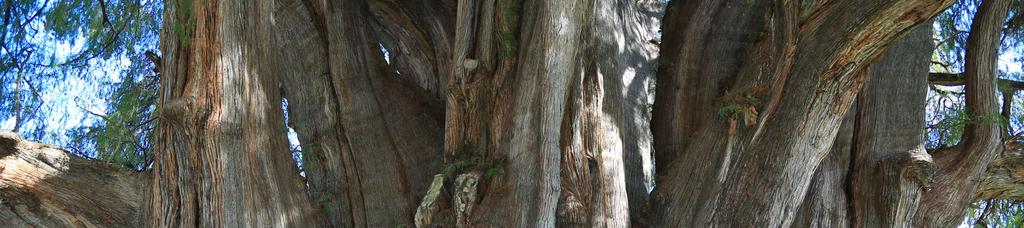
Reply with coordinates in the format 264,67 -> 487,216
797,24 -> 935,227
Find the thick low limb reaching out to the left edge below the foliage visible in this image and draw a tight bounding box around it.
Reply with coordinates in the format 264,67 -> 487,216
0,132 -> 145,228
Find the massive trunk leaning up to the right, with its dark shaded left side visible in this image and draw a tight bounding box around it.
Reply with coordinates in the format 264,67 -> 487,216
648,1 -> 951,227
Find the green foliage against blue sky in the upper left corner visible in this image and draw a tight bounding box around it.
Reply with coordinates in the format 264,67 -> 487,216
0,0 -> 163,149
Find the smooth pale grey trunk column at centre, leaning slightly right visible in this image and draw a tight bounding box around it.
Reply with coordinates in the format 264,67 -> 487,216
468,1 -> 591,227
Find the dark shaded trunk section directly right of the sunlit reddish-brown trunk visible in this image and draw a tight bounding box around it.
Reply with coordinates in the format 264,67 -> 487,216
279,1 -> 441,227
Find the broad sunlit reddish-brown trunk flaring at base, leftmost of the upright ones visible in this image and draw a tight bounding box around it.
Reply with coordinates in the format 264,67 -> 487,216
144,0 -> 312,224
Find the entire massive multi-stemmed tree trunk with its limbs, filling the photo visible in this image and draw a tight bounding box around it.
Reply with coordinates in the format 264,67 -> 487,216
9,0 -> 1024,227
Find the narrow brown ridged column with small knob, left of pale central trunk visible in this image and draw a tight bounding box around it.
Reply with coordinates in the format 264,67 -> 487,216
439,0 -> 516,224
